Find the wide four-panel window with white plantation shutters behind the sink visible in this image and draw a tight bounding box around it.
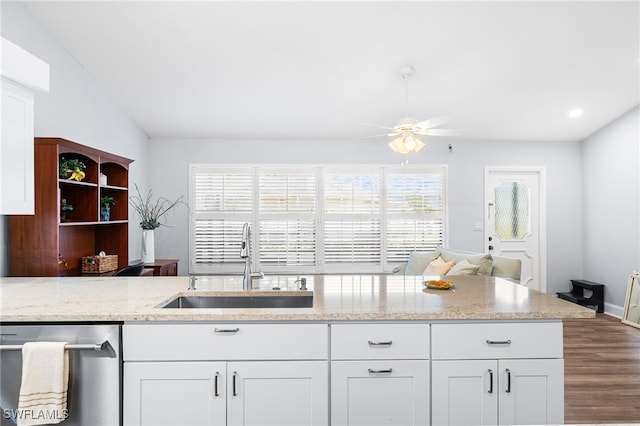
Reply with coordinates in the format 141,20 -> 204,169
189,165 -> 446,273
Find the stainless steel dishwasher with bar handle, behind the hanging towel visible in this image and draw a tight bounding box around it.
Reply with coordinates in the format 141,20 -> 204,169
0,323 -> 122,426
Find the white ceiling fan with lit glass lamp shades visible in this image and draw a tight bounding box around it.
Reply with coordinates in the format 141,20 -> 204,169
368,65 -> 464,154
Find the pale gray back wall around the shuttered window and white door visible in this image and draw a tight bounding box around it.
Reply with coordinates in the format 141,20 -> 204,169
149,139 -> 582,293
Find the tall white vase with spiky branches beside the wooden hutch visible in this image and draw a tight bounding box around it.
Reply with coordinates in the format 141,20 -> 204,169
129,185 -> 185,264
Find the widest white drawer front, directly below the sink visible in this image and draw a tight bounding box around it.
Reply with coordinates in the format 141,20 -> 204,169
122,324 -> 329,361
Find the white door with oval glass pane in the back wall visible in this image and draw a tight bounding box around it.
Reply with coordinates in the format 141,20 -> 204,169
484,167 -> 547,292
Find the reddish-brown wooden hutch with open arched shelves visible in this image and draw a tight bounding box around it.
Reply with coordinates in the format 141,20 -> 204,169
9,138 -> 133,276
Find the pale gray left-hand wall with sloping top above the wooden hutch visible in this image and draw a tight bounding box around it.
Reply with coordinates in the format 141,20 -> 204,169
0,1 -> 148,276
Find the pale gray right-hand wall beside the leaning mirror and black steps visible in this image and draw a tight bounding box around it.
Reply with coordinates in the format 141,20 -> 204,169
582,107 -> 640,314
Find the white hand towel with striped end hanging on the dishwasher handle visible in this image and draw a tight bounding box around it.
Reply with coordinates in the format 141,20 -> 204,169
17,342 -> 69,426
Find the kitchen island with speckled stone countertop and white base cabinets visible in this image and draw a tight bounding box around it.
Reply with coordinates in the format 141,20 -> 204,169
0,275 -> 595,425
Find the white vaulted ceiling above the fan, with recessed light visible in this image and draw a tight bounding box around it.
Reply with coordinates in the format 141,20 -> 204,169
26,1 -> 640,141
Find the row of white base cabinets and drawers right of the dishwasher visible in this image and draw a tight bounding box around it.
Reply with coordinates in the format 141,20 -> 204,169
122,321 -> 564,426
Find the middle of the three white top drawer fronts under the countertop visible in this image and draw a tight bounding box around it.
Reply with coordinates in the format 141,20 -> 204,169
331,324 -> 429,360
